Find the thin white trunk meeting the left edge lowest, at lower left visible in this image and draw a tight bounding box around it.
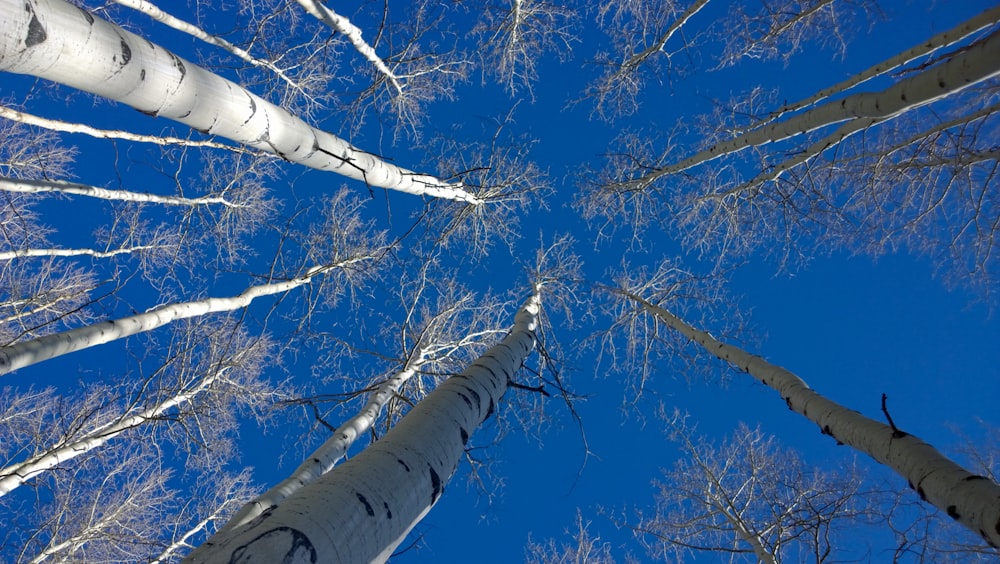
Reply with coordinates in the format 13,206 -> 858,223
0,367 -> 228,497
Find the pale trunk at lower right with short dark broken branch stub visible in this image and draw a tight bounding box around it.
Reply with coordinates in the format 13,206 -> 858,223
623,292 -> 1000,547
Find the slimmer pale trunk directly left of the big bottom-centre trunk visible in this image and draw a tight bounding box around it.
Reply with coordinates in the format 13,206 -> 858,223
221,353 -> 425,530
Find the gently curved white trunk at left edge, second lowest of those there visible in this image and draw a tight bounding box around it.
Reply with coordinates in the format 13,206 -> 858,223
0,258 -> 365,375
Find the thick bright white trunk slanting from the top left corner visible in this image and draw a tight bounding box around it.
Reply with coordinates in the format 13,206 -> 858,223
0,0 -> 481,204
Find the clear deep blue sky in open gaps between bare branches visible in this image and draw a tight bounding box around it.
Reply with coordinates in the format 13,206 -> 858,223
0,1 -> 1000,563
